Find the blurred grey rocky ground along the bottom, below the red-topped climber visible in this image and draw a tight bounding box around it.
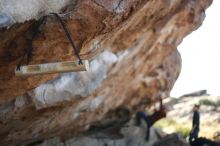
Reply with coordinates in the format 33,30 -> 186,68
21,121 -> 189,146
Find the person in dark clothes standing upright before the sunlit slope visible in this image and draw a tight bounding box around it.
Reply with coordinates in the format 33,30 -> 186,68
189,104 -> 200,145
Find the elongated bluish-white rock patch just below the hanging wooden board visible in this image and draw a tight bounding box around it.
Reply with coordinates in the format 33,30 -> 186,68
31,51 -> 118,109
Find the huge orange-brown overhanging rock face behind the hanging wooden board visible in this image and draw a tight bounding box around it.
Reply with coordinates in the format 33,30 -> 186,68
0,0 -> 212,145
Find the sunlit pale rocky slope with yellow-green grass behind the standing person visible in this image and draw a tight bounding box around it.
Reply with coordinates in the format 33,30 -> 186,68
157,95 -> 220,141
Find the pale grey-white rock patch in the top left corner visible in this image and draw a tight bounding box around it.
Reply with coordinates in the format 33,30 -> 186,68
0,0 -> 72,24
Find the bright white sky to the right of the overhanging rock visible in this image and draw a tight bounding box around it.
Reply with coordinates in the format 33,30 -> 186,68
171,0 -> 220,97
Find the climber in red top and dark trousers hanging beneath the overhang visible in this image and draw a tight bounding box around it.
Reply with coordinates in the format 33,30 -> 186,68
136,99 -> 166,141
